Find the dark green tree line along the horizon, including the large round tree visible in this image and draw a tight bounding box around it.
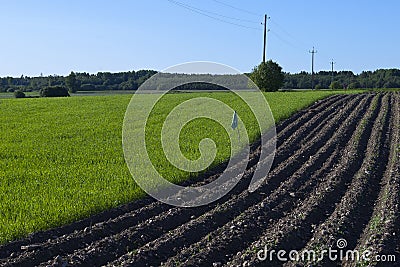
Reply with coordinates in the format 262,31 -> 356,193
0,67 -> 400,92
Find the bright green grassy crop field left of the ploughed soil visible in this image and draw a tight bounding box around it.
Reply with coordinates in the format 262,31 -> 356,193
0,91 -> 354,243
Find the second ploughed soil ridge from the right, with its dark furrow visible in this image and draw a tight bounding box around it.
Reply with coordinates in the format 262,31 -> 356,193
287,95 -> 390,266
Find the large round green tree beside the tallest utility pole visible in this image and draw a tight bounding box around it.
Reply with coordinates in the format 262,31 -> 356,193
250,60 -> 285,92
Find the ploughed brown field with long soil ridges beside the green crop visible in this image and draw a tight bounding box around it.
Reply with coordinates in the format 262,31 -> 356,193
0,93 -> 400,266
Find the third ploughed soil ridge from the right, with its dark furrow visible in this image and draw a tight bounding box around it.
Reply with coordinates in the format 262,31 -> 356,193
225,93 -> 380,266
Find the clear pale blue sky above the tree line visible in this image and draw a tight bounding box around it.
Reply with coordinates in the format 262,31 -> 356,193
0,0 -> 400,76
